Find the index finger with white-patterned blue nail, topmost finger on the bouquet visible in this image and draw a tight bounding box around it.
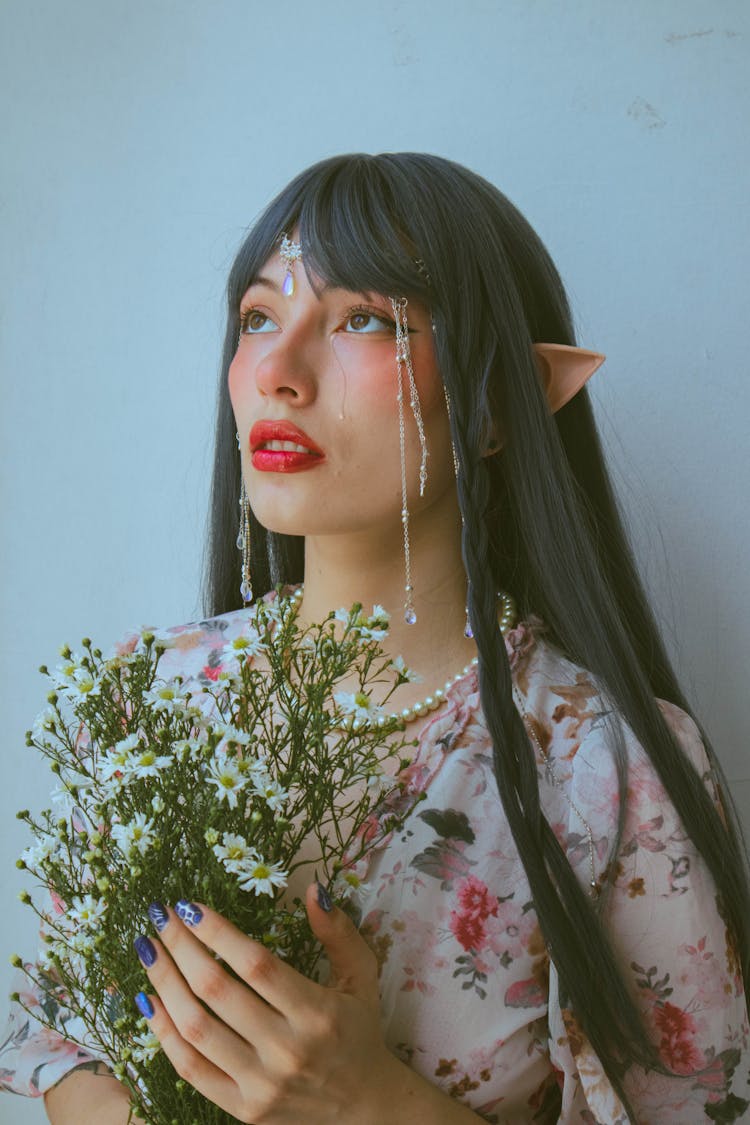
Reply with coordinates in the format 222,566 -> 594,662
164,900 -> 324,1029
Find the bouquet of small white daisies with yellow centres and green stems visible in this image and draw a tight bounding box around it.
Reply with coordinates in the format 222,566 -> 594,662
11,590 -> 422,1125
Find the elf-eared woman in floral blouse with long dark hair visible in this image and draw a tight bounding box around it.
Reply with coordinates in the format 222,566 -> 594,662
2,154 -> 750,1125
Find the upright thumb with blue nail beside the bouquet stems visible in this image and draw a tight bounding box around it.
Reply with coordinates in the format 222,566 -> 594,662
306,882 -> 378,1002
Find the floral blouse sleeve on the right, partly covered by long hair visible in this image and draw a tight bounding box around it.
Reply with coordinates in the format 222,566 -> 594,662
549,701 -> 750,1125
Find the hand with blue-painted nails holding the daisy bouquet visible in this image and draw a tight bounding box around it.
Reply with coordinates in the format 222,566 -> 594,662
133,884 -> 404,1125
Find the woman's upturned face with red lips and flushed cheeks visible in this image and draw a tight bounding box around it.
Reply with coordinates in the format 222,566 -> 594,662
228,241 -> 455,537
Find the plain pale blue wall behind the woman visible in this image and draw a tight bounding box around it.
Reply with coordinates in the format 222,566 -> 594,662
0,0 -> 750,1125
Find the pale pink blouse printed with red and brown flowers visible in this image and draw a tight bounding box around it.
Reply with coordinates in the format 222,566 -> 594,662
0,594 -> 750,1125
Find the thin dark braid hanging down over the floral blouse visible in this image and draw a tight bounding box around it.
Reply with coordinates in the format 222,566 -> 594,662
442,321 -> 662,1105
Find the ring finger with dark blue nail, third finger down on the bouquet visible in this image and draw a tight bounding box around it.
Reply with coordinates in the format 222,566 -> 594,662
136,926 -> 257,1078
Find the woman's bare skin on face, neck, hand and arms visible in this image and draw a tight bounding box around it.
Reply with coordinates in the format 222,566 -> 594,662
46,241 -> 492,1125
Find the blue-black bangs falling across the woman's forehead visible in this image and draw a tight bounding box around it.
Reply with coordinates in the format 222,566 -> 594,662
228,155 -> 430,314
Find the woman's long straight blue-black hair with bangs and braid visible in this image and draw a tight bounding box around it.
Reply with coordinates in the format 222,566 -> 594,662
205,153 -> 750,1100
